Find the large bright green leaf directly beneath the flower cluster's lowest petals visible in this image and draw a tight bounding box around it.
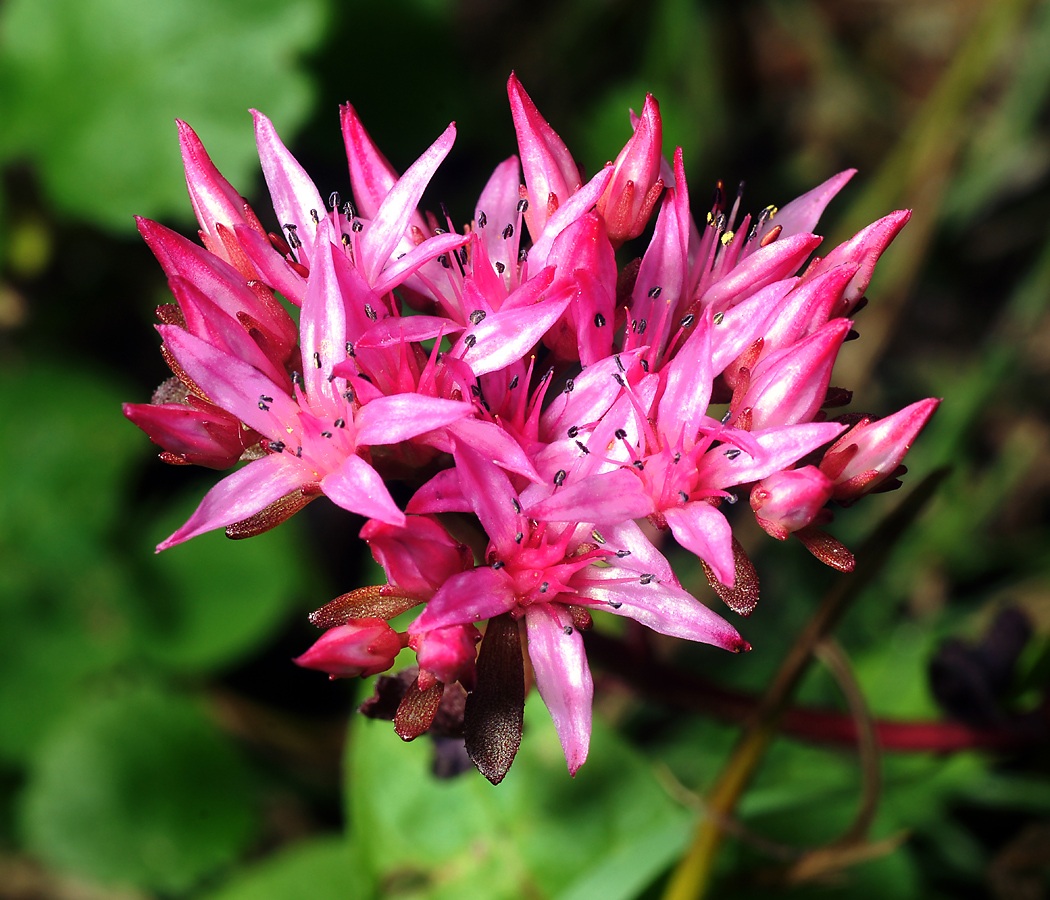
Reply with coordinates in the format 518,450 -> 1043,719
349,696 -> 691,900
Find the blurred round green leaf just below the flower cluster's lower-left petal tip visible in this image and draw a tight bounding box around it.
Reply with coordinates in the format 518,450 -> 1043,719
135,491 -> 306,671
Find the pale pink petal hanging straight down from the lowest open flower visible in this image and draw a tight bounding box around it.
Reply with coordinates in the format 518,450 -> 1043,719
525,603 -> 594,775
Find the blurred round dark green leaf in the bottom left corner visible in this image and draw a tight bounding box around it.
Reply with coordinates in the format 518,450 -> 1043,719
22,690 -> 254,892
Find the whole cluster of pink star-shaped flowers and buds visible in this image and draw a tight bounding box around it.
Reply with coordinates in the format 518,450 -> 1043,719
125,76 -> 939,781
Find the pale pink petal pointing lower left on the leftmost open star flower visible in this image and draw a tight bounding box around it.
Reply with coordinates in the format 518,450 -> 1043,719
156,454 -> 317,552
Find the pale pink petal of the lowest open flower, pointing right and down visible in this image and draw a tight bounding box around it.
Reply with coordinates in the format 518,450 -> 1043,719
574,566 -> 747,651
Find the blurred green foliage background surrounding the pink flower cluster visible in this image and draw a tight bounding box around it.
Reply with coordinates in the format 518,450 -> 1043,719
0,0 -> 1050,900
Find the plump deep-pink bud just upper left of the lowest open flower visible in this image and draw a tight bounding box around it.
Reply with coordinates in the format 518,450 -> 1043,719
361,516 -> 474,599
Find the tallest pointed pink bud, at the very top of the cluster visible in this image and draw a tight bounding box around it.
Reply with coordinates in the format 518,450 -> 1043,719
507,72 -> 583,240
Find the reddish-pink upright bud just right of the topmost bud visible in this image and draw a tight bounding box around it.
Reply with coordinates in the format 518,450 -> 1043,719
597,93 -> 664,246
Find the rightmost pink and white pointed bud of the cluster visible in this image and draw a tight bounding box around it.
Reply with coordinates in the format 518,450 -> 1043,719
820,397 -> 941,500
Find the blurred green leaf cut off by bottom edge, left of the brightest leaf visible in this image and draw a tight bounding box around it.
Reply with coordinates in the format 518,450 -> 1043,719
205,837 -> 372,900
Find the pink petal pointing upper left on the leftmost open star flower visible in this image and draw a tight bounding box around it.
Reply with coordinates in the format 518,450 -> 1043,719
156,325 -> 299,441
